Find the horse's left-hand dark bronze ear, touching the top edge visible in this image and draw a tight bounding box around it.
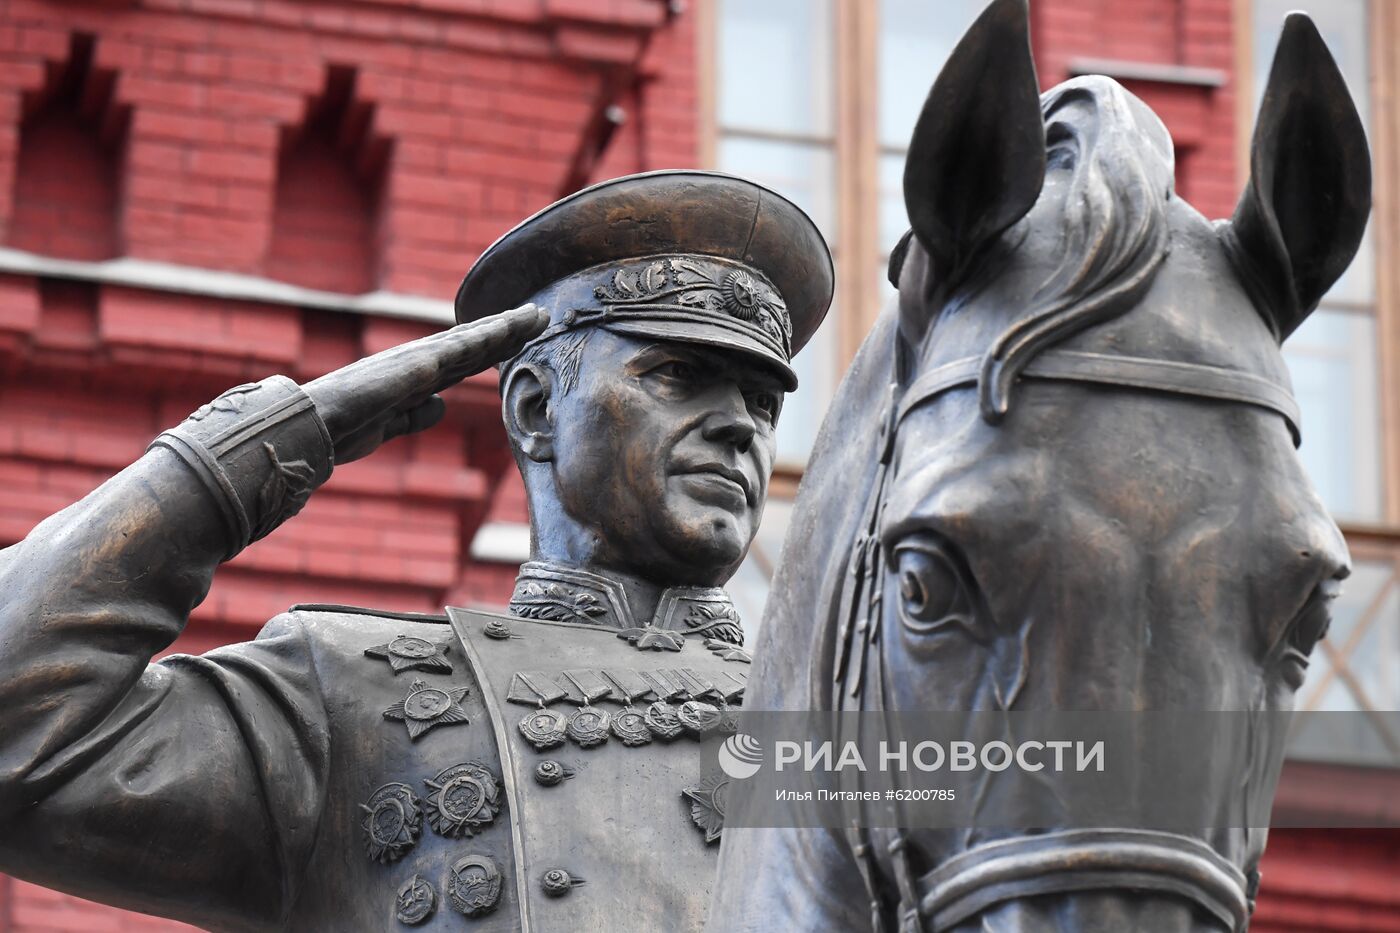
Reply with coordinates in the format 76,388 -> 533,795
904,0 -> 1046,289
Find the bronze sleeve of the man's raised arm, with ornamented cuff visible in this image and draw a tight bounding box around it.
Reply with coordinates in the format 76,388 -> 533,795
0,377 -> 329,930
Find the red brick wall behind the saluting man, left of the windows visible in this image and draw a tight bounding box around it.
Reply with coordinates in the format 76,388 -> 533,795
0,0 -> 697,933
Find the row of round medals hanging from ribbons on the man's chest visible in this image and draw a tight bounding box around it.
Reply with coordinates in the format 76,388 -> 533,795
505,667 -> 748,751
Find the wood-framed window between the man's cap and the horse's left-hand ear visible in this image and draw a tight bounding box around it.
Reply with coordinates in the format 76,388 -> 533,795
700,0 -> 986,633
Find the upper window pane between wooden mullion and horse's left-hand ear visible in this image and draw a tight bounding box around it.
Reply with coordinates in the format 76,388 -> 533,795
878,0 -> 987,147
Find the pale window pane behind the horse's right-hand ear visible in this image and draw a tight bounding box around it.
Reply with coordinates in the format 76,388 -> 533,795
1253,0 -> 1376,304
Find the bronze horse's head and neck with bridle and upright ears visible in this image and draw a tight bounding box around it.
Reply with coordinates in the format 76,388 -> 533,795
708,0 -> 1371,933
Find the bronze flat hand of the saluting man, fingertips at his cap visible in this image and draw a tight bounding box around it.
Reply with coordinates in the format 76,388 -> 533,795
302,304 -> 549,464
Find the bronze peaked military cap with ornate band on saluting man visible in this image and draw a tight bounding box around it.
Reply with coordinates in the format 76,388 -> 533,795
456,171 -> 834,389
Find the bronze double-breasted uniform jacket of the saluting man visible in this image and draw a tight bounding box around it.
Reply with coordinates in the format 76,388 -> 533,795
0,381 -> 748,933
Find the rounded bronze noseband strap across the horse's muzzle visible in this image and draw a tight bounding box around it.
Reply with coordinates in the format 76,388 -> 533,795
918,829 -> 1250,933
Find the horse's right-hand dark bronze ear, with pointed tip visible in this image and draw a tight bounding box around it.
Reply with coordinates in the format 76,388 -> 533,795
1224,13 -> 1371,340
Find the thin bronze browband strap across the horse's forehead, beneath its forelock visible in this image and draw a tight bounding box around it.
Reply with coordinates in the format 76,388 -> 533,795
896,350 -> 1302,445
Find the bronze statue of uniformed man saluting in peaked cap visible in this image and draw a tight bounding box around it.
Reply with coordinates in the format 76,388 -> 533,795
0,172 -> 832,932
